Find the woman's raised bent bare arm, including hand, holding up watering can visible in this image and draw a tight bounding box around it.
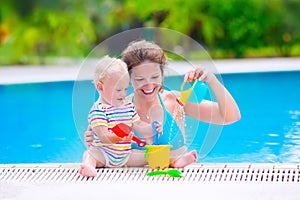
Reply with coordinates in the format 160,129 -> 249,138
184,68 -> 241,124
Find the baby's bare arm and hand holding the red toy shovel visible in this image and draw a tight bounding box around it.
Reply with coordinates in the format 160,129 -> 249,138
93,125 -> 133,144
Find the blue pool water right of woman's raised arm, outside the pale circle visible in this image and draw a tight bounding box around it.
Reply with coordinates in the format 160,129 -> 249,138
206,71 -> 300,163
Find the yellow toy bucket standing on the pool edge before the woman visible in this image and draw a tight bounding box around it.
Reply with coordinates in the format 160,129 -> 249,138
145,145 -> 172,169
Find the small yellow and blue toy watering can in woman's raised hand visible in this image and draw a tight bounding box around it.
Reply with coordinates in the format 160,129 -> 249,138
176,79 -> 207,106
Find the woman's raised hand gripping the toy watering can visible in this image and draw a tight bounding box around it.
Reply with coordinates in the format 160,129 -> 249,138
184,68 -> 216,83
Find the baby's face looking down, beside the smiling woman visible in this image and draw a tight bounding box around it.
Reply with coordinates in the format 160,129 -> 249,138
101,73 -> 130,107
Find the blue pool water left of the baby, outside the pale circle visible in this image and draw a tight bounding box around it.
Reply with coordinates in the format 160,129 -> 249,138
0,82 -> 84,163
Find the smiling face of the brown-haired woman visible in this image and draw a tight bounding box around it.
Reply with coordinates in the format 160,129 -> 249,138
131,62 -> 162,101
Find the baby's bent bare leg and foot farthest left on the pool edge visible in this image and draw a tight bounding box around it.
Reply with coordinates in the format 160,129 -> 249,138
79,149 -> 105,177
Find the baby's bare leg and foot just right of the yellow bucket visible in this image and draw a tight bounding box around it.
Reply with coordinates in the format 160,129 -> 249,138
170,147 -> 197,168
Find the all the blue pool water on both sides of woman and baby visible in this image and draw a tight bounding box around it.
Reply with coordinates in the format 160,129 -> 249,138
0,71 -> 300,163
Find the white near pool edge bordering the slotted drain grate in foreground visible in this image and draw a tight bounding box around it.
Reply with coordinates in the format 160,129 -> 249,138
0,163 -> 300,200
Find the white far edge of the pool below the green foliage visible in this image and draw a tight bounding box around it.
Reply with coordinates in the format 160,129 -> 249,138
0,57 -> 300,84
